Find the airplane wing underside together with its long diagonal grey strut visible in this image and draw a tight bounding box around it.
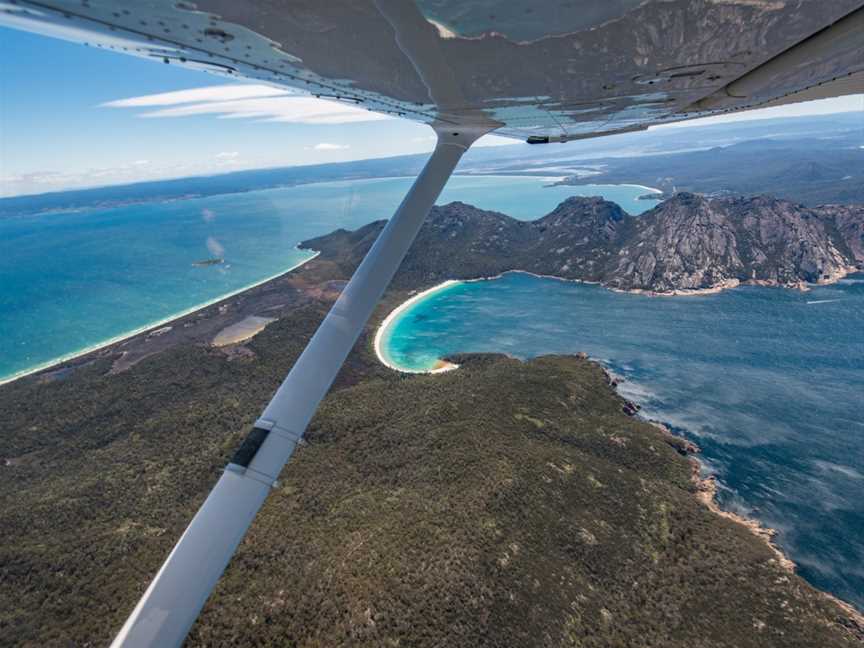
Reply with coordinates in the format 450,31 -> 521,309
0,0 -> 864,648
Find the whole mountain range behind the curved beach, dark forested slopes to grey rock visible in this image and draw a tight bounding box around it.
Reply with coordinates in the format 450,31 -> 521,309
303,193 -> 864,293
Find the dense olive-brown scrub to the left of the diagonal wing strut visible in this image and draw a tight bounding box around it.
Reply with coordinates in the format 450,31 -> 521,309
0,305 -> 382,646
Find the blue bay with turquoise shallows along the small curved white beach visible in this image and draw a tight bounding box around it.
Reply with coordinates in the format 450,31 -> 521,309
383,273 -> 864,608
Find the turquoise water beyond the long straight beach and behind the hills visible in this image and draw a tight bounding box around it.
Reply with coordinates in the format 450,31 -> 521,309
0,176 -> 655,381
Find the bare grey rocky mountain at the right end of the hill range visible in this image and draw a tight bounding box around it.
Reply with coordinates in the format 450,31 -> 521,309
604,194 -> 864,292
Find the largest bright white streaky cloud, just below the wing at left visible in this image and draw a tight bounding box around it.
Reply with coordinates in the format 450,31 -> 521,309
102,85 -> 392,124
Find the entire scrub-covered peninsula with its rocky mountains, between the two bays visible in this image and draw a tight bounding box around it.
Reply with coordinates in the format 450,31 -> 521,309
0,197 -> 864,648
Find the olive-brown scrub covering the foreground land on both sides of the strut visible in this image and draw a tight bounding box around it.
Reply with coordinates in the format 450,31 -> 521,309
0,344 -> 855,647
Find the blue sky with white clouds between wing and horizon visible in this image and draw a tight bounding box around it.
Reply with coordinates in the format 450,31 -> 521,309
0,28 -> 864,195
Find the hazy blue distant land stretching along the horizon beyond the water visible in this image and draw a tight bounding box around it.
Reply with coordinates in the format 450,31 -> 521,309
0,113 -> 864,217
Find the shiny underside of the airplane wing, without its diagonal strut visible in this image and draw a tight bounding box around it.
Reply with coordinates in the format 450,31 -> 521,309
0,0 -> 864,143
